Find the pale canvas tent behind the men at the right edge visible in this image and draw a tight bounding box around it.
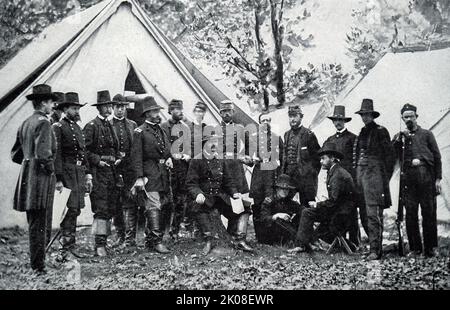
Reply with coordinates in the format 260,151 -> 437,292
313,48 -> 450,228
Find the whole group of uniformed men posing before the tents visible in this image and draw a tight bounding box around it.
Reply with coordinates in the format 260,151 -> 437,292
12,84 -> 442,272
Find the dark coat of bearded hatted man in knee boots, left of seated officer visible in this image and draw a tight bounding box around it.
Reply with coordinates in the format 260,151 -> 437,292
131,122 -> 170,192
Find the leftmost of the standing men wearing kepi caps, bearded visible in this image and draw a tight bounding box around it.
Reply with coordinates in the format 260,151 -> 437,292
161,99 -> 191,239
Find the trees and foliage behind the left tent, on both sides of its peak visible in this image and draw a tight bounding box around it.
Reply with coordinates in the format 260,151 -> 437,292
0,0 -> 352,109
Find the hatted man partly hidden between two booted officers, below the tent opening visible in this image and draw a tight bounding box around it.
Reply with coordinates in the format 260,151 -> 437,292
111,94 -> 137,246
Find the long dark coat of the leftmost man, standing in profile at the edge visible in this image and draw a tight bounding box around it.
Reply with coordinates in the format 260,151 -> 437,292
12,111 -> 56,212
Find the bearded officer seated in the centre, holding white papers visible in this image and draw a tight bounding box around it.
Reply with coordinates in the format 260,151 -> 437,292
186,134 -> 246,255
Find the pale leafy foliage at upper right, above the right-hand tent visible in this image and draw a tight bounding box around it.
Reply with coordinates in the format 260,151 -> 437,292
347,0 -> 450,75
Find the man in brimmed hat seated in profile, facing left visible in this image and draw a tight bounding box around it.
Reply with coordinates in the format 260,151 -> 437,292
297,143 -> 354,252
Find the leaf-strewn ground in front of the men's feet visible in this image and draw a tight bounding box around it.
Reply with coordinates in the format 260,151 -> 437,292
0,228 -> 450,289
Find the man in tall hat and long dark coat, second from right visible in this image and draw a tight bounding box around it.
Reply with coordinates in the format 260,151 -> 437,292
353,99 -> 394,260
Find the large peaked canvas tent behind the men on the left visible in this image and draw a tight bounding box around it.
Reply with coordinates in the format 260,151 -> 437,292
0,0 -> 253,227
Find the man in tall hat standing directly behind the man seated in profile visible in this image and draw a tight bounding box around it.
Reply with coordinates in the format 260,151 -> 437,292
323,105 -> 360,246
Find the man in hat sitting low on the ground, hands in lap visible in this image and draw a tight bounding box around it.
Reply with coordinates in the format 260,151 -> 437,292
261,174 -> 304,244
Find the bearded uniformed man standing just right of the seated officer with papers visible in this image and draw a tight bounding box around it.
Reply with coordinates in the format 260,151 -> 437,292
250,114 -> 283,243
